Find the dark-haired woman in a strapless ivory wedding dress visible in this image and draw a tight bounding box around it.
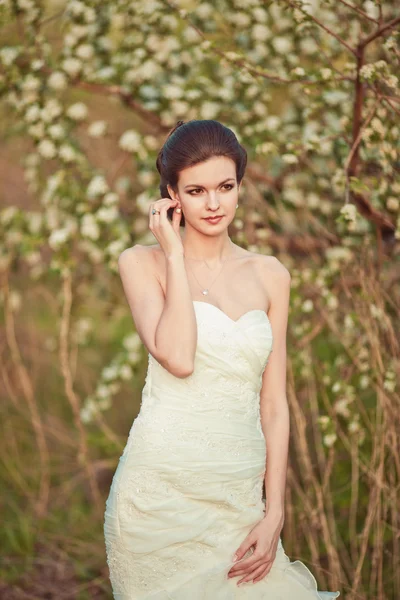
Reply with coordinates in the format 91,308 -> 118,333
104,120 -> 339,600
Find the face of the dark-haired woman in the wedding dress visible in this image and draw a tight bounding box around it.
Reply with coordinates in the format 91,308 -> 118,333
167,156 -> 242,233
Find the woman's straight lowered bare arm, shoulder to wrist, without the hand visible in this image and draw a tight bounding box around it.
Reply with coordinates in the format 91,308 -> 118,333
260,257 -> 291,515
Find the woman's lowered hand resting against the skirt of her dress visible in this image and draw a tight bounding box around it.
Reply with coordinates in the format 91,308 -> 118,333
228,510 -> 284,585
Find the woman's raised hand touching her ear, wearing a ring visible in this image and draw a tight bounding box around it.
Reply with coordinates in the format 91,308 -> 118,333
149,198 -> 184,257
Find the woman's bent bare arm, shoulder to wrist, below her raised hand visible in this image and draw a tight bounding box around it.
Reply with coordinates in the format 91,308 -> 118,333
118,244 -> 197,378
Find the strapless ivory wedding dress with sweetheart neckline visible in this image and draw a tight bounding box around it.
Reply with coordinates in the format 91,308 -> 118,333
104,300 -> 340,600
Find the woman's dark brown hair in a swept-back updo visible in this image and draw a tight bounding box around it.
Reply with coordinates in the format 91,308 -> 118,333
156,119 -> 247,226
